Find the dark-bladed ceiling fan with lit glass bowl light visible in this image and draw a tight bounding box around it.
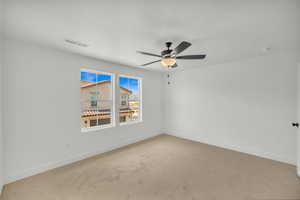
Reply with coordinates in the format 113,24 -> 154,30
138,41 -> 206,68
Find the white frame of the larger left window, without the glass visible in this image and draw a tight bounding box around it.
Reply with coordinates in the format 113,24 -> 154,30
79,68 -> 116,132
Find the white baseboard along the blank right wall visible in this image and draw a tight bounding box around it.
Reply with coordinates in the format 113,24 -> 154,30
168,131 -> 299,166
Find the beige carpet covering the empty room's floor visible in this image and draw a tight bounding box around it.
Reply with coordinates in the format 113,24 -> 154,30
1,135 -> 300,200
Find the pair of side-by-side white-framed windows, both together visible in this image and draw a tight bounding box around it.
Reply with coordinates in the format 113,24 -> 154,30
80,69 -> 142,131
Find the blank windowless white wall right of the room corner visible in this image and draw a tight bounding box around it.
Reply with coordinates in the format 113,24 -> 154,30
164,53 -> 300,164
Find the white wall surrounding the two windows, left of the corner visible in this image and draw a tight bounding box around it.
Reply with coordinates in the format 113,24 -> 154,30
4,39 -> 163,182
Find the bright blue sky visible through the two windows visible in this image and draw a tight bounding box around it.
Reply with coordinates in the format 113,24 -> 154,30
80,72 -> 139,92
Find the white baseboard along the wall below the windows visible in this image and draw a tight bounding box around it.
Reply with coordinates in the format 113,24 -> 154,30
5,133 -> 161,184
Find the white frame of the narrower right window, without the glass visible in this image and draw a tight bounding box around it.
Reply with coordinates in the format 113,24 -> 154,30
116,74 -> 143,126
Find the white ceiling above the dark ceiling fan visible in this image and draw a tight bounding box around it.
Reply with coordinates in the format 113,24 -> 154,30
5,0 -> 300,70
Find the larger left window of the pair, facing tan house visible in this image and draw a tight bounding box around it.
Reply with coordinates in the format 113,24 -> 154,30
80,70 -> 114,130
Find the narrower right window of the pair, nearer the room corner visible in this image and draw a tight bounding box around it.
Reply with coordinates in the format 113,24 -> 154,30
119,75 -> 142,124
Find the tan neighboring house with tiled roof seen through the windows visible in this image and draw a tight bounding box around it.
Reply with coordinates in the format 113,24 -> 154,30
80,80 -> 134,128
